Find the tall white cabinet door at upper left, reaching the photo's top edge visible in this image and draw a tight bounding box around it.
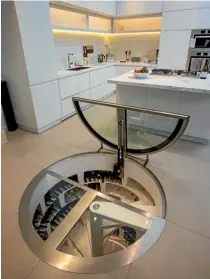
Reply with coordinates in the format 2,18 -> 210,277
14,1 -> 57,85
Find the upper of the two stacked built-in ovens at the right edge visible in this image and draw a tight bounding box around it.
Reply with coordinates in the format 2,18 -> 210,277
190,29 -> 210,49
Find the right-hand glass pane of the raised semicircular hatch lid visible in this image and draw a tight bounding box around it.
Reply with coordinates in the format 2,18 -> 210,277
126,110 -> 183,153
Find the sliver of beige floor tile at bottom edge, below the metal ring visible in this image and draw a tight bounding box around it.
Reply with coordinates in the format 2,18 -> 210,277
27,262 -> 113,279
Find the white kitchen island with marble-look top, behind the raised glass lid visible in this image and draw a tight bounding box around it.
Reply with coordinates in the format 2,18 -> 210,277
108,73 -> 210,144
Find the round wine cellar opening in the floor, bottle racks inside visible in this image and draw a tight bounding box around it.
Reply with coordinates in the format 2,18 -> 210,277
19,152 -> 166,273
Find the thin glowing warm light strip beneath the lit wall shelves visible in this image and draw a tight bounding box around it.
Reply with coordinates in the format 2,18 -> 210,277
52,29 -> 160,37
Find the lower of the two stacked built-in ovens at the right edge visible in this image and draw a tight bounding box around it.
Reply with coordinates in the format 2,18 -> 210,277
186,49 -> 210,72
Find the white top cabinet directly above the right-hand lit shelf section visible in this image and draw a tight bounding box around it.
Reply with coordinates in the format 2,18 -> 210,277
117,1 -> 163,16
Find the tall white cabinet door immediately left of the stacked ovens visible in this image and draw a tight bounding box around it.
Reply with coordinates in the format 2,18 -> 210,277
158,30 -> 191,70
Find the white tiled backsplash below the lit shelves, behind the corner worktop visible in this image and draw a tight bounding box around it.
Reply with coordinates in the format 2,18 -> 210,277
53,31 -> 160,69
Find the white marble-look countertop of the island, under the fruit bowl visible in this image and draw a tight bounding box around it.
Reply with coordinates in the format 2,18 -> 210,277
108,73 -> 210,94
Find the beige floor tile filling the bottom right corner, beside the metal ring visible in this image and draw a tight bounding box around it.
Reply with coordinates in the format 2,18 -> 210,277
129,222 -> 210,279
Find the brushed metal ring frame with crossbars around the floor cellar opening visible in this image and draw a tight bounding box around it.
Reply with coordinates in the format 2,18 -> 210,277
19,152 -> 166,274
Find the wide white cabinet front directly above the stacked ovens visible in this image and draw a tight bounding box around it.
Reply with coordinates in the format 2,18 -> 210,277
162,8 -> 210,31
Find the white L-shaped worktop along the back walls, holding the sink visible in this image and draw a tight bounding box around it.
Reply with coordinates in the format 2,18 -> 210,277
57,61 -> 157,78
